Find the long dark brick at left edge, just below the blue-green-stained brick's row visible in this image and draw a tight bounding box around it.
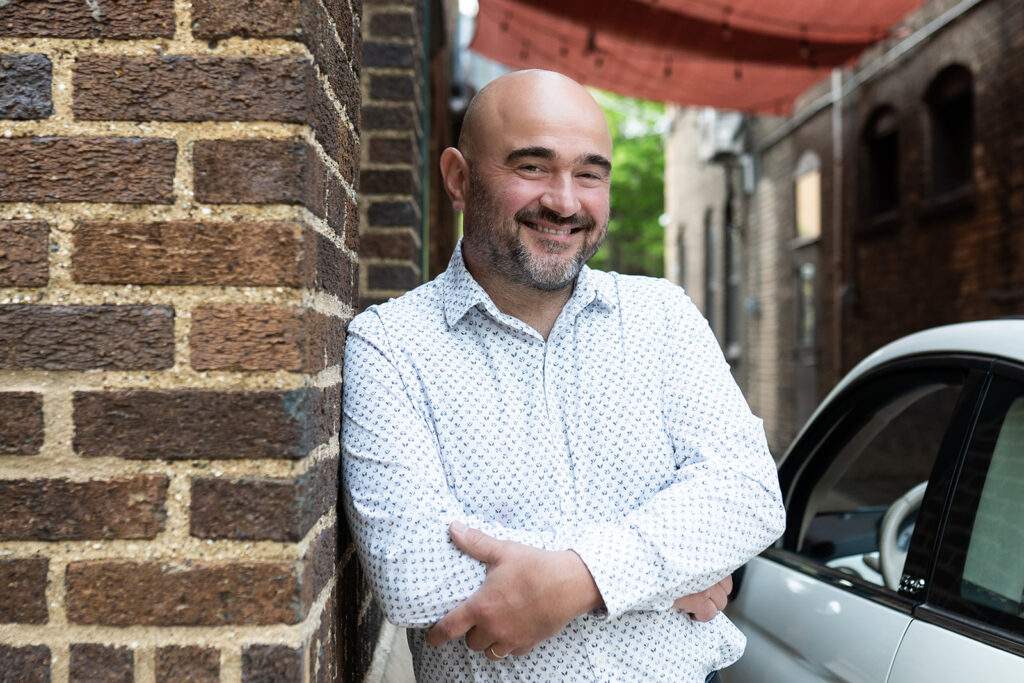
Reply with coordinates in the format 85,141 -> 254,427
0,475 -> 167,541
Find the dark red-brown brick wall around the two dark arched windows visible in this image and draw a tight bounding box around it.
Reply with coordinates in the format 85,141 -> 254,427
842,0 -> 1024,368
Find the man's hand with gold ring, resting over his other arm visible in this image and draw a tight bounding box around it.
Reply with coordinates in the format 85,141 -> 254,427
427,522 -> 603,660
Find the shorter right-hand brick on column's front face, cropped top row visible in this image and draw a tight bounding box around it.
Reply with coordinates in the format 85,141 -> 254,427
193,0 -> 299,39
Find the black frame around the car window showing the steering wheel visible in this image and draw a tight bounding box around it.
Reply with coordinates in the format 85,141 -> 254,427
762,353 -> 991,614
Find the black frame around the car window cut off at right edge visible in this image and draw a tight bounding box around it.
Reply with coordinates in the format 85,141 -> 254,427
914,360 -> 1024,656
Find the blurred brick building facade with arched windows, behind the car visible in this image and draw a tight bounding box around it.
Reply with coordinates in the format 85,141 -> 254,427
666,0 -> 1024,455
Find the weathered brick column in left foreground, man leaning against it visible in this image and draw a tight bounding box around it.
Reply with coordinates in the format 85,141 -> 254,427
0,0 -> 368,682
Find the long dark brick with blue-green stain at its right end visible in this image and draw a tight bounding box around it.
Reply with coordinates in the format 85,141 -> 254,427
74,389 -> 339,460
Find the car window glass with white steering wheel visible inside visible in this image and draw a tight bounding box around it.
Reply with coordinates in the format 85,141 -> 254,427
798,374 -> 963,590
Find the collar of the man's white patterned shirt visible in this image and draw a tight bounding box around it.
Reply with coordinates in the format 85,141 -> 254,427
443,240 -> 615,328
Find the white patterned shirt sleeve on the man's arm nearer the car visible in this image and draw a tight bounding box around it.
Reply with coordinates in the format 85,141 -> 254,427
569,288 -> 785,618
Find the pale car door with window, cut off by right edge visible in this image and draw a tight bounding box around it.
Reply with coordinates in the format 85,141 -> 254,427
889,362 -> 1024,683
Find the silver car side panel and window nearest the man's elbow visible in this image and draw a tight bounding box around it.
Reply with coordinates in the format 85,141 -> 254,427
723,358 -> 987,683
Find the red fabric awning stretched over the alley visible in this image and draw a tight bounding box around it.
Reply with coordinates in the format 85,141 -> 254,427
470,0 -> 923,114
